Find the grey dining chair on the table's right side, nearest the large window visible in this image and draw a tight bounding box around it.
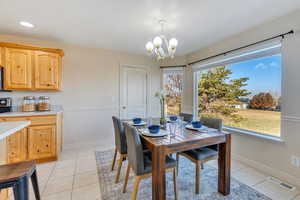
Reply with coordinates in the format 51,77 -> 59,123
176,117 -> 222,194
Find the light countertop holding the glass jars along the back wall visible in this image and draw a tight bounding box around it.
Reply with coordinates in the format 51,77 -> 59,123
0,106 -> 63,117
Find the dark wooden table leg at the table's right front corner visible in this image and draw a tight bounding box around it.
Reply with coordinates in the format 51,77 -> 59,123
218,134 -> 231,196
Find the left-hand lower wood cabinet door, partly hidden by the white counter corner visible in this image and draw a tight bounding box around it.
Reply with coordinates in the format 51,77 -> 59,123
6,128 -> 27,163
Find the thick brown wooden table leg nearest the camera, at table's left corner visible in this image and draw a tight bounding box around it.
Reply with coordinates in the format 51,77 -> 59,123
152,146 -> 166,200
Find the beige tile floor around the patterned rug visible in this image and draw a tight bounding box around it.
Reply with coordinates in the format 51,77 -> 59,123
7,145 -> 300,200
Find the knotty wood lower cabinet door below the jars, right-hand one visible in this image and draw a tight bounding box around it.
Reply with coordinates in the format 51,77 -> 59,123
28,125 -> 56,160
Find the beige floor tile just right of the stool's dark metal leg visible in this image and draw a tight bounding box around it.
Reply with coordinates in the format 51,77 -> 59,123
43,176 -> 74,196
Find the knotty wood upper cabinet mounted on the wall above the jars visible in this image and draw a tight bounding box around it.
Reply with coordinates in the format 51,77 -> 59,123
0,42 -> 64,91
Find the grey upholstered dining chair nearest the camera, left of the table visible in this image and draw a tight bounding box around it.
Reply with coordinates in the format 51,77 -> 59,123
123,124 -> 177,200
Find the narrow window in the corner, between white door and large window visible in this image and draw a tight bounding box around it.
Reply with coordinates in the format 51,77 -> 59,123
163,69 -> 183,115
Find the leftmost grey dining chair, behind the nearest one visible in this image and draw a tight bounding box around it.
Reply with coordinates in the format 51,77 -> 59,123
111,116 -> 127,183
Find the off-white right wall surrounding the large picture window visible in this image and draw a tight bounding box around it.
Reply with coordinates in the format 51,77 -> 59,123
163,10 -> 300,186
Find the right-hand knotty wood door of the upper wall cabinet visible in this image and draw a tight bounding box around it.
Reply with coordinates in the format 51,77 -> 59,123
35,51 -> 61,90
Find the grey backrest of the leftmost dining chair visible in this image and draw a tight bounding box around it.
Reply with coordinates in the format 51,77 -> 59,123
112,116 -> 127,154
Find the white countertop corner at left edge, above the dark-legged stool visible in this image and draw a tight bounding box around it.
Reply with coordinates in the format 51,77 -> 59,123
0,121 -> 30,140
